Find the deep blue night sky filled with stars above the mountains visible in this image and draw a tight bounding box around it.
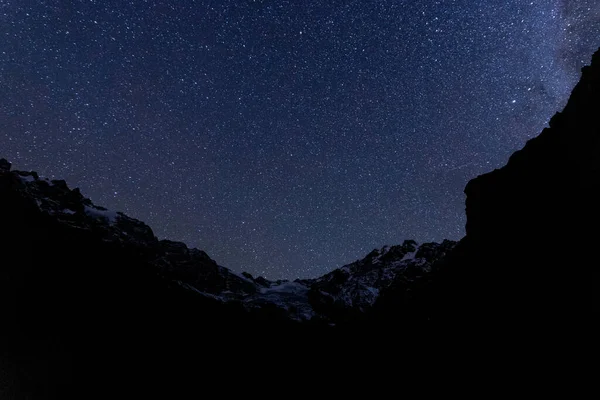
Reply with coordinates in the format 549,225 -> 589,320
0,0 -> 600,279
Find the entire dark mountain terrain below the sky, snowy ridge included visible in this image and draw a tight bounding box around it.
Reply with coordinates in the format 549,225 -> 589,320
0,51 -> 600,399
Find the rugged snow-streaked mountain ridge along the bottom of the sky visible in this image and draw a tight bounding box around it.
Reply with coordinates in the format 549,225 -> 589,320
0,160 -> 455,323
